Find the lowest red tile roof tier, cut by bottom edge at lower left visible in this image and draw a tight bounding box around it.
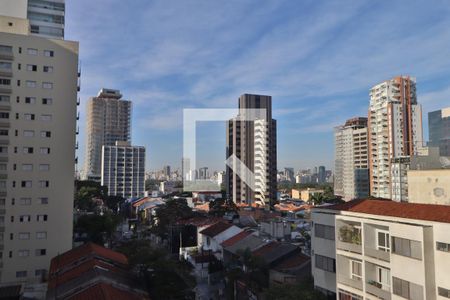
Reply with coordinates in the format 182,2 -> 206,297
67,283 -> 149,300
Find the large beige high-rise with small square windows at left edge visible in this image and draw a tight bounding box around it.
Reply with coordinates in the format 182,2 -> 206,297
0,8 -> 79,284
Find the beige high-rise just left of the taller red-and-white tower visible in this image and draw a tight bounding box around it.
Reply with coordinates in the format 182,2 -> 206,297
334,117 -> 369,201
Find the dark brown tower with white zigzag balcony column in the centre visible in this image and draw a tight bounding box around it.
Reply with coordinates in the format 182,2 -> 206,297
226,94 -> 277,205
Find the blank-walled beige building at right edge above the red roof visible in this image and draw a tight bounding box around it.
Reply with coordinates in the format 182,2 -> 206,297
408,169 -> 450,205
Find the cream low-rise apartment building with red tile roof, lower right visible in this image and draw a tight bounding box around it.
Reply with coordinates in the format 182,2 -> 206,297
311,200 -> 450,300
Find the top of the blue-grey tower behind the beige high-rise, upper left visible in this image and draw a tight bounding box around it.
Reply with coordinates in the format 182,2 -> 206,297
0,0 -> 65,39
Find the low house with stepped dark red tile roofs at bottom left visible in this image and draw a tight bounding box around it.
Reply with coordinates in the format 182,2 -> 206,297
47,243 -> 149,300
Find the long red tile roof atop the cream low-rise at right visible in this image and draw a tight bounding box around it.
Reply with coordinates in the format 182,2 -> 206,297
323,199 -> 450,223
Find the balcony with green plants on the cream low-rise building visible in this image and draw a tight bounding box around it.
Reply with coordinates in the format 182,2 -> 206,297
336,220 -> 362,254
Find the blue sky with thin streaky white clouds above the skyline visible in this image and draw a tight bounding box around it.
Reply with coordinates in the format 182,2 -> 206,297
66,0 -> 450,170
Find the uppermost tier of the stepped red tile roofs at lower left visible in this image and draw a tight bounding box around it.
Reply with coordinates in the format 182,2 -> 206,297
49,243 -> 128,275
